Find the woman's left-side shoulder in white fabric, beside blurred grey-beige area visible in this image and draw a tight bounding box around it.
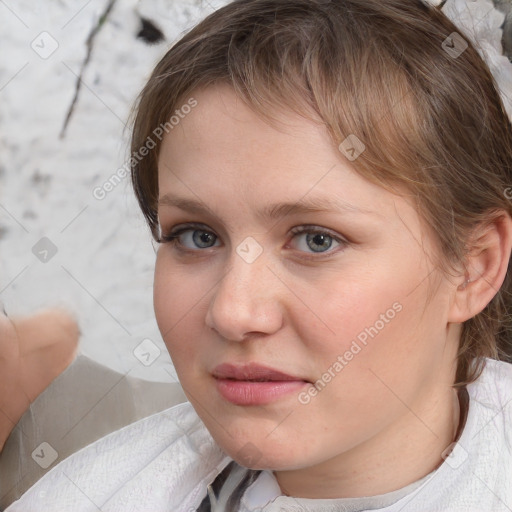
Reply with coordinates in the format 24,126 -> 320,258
7,402 -> 230,512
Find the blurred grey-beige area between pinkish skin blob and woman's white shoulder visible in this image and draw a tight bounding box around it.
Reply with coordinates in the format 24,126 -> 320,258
0,354 -> 187,510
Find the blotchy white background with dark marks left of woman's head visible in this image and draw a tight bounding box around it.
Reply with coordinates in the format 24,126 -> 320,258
0,0 -> 505,381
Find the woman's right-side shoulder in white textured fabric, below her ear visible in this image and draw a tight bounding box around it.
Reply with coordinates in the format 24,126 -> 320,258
383,359 -> 512,512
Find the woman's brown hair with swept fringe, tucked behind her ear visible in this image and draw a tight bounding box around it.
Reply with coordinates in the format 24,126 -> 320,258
131,0 -> 512,386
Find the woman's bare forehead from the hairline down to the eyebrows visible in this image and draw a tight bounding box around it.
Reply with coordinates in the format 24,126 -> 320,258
155,86 -> 404,228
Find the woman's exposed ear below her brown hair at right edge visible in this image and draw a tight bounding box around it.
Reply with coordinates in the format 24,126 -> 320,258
448,210 -> 512,323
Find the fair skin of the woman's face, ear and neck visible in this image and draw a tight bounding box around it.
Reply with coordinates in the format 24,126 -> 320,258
154,86 -> 512,498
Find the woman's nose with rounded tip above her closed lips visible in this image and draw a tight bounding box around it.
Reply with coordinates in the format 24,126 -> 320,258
205,253 -> 283,341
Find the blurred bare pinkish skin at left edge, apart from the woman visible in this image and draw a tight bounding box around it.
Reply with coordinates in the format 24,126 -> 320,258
0,310 -> 79,451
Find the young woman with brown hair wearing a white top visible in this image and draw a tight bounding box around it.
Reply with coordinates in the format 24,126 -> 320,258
9,0 -> 512,512
